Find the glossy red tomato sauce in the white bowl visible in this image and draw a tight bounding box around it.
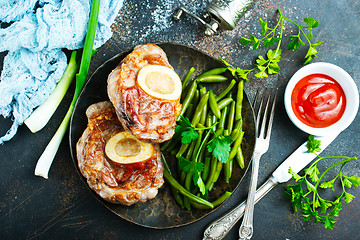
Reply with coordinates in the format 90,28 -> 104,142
291,74 -> 346,128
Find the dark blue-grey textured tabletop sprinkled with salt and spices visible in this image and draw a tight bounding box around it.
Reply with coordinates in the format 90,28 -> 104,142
0,0 -> 360,240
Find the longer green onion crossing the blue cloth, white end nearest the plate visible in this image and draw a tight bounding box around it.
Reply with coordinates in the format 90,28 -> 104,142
35,0 -> 100,178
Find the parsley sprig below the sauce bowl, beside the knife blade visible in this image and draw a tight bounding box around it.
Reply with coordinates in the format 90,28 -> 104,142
285,135 -> 360,229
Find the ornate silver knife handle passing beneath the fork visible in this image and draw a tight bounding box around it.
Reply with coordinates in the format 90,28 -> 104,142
203,176 -> 278,240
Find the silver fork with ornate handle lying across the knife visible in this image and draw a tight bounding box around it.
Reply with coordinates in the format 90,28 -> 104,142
239,90 -> 277,240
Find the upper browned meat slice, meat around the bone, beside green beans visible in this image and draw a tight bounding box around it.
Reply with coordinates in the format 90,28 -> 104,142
107,44 -> 181,143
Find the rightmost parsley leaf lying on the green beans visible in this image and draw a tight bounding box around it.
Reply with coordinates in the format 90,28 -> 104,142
206,135 -> 233,163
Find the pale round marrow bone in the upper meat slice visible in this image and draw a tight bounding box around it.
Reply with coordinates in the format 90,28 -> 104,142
137,65 -> 181,100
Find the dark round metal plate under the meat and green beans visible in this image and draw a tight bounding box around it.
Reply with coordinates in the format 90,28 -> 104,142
69,43 -> 255,229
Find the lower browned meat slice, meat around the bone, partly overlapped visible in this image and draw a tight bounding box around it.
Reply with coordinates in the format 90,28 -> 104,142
76,101 -> 164,206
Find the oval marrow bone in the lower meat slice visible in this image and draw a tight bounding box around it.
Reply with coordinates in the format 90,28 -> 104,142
105,131 -> 154,164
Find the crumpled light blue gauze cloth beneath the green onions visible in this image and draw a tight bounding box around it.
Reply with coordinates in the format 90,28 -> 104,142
0,0 -> 123,144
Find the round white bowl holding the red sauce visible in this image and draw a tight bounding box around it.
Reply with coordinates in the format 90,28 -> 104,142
284,62 -> 359,136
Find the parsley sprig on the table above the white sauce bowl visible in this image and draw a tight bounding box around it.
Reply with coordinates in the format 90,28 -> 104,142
223,9 -> 323,81
